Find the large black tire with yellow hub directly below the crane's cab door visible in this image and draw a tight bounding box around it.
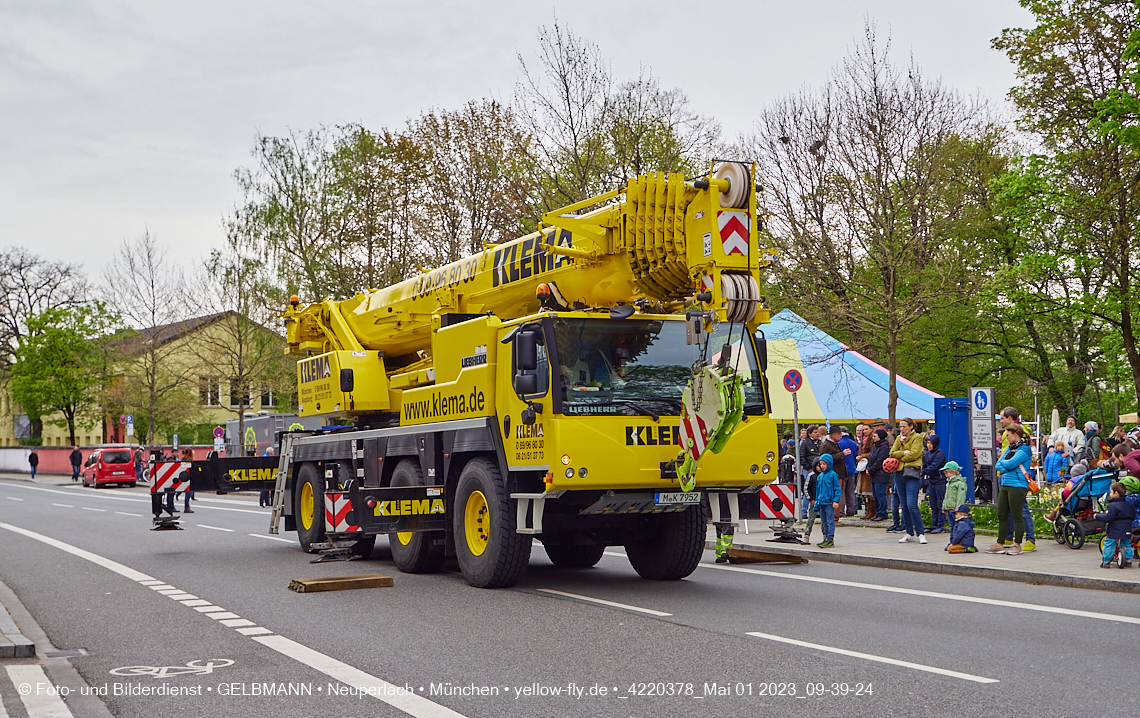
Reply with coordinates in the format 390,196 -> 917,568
451,457 -> 531,588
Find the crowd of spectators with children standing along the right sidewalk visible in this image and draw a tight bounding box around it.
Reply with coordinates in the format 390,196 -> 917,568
781,407 -> 1140,568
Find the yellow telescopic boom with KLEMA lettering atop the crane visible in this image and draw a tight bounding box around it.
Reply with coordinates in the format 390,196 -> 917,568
284,162 -> 775,369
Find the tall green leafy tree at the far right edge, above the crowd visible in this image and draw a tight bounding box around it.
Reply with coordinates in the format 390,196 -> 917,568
994,0 -> 1140,410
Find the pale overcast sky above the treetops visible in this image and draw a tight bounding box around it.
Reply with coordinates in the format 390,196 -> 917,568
0,0 -> 1031,275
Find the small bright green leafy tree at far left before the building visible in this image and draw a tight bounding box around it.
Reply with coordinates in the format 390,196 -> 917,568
10,303 -> 121,444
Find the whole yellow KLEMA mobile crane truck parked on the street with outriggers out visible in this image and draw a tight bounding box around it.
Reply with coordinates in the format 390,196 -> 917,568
182,162 -> 777,587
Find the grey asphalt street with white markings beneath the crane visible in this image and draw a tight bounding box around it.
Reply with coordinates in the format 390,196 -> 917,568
0,481 -> 1140,718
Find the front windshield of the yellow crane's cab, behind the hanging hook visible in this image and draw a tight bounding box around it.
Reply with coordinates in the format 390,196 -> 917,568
554,319 -> 766,416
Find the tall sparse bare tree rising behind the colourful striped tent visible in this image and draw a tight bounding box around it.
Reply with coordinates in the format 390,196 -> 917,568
747,24 -> 988,421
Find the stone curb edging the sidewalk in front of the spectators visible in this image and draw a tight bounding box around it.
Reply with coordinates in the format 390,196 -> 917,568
705,541 -> 1140,594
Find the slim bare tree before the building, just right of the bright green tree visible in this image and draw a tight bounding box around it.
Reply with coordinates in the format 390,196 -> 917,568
100,231 -> 196,443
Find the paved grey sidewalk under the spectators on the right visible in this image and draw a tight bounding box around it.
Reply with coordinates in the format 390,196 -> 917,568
706,519 -> 1140,594
